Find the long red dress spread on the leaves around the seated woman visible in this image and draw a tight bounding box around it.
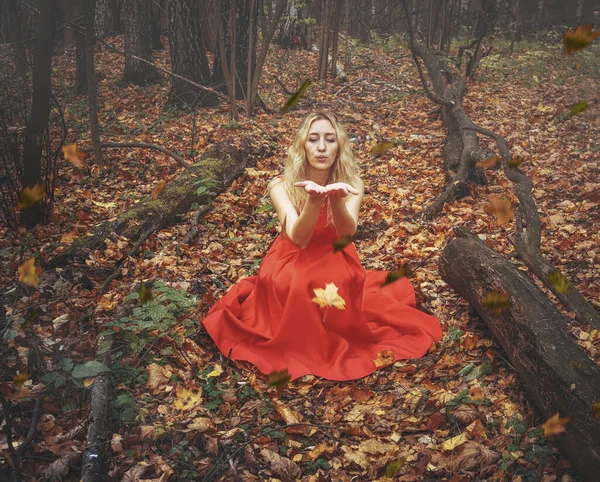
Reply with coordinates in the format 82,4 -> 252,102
202,203 -> 442,380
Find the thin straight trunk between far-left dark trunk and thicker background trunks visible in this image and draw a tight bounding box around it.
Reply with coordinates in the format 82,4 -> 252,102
83,0 -> 104,165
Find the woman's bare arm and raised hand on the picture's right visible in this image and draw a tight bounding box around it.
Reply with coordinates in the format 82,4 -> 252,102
326,179 -> 365,237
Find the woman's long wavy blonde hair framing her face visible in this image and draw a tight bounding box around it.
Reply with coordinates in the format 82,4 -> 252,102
283,111 -> 360,211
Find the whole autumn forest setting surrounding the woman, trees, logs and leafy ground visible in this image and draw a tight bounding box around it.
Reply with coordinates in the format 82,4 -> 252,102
0,0 -> 600,481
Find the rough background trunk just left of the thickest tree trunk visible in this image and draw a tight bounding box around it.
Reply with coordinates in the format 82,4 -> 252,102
123,0 -> 158,85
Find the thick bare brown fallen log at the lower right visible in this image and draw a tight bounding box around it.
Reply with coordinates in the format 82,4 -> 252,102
438,229 -> 600,481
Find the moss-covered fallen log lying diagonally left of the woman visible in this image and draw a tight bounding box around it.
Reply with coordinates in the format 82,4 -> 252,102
45,137 -> 270,269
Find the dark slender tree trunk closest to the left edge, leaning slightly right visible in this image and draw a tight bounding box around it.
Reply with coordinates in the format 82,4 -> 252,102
21,0 -> 57,227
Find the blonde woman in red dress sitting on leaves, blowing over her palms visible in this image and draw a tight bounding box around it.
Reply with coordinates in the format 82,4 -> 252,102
203,112 -> 442,380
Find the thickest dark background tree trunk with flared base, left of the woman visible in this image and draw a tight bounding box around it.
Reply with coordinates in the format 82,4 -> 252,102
167,0 -> 219,107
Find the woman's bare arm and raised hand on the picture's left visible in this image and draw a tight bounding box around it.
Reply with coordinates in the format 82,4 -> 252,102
269,180 -> 327,249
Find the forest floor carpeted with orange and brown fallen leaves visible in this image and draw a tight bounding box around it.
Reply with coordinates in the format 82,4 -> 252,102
0,37 -> 600,482
